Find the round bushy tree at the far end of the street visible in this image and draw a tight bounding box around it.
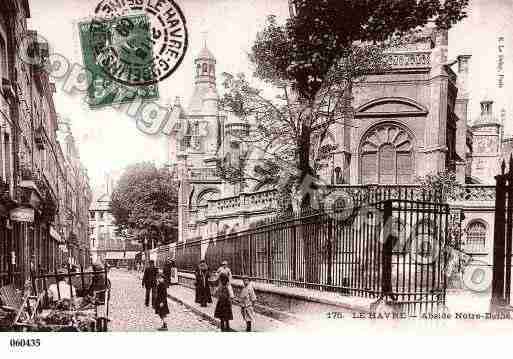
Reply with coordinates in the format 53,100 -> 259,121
111,162 -> 178,247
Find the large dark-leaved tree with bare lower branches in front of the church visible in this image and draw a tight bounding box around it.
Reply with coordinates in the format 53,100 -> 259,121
220,0 -> 468,210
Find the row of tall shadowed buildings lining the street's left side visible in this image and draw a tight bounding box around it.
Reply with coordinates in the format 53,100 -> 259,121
0,0 -> 91,286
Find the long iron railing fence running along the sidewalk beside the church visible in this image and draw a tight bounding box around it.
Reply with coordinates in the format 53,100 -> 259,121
172,187 -> 449,312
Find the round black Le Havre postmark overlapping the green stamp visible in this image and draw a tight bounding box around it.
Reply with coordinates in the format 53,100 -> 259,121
93,0 -> 188,85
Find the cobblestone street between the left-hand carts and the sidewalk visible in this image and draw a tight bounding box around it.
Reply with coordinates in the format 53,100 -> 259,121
109,269 -> 217,332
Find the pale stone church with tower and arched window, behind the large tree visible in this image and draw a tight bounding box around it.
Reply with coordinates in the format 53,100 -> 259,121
170,28 -> 506,264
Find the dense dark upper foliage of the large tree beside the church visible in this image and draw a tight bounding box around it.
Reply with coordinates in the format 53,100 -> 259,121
250,0 -> 468,100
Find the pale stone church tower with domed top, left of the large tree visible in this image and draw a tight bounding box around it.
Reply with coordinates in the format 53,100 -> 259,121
169,43 -> 221,241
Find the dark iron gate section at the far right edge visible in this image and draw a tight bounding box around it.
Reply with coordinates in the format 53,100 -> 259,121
490,157 -> 513,311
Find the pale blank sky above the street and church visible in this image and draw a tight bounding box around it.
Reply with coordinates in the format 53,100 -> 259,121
29,0 -> 513,188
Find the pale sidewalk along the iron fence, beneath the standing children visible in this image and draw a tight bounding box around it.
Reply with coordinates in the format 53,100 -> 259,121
167,285 -> 290,332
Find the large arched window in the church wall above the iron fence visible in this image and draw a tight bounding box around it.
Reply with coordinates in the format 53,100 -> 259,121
360,123 -> 414,184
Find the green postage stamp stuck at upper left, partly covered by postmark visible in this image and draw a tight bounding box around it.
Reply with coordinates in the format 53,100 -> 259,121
79,14 -> 159,108
